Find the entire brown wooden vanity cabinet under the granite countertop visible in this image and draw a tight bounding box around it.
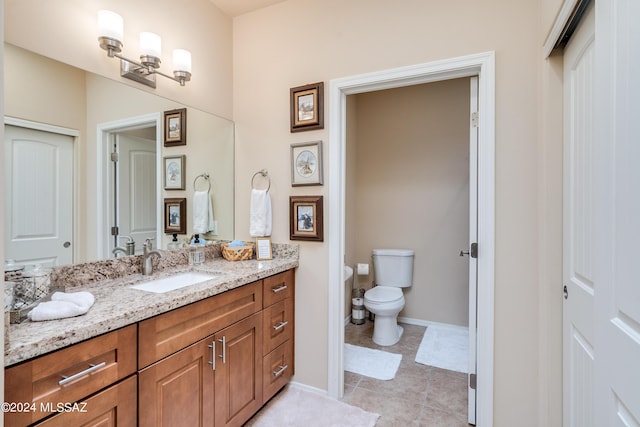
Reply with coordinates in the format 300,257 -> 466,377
5,270 -> 295,427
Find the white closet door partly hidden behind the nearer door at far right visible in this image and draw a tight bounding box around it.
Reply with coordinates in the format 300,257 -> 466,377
563,7 -> 604,427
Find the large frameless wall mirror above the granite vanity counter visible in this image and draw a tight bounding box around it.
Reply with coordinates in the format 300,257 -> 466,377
3,44 -> 234,265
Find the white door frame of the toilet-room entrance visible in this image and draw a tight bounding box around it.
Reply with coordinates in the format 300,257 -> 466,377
327,51 -> 495,426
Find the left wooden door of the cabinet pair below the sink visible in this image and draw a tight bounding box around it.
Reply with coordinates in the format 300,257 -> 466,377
138,337 -> 215,427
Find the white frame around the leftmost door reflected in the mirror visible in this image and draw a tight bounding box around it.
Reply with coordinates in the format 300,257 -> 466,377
4,116 -> 80,262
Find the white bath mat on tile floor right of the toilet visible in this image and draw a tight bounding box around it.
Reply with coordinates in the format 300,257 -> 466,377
416,325 -> 469,373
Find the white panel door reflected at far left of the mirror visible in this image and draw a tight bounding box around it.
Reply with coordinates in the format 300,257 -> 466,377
4,125 -> 74,266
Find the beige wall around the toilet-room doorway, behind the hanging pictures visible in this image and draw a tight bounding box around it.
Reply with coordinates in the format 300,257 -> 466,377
234,0 -> 561,426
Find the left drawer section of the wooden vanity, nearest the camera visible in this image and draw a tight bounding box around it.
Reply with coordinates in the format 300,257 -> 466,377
4,325 -> 137,426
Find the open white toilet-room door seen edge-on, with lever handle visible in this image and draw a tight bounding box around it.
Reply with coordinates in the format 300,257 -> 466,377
467,77 -> 478,424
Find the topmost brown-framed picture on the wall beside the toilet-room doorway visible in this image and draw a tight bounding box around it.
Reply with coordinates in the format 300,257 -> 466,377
289,82 -> 324,132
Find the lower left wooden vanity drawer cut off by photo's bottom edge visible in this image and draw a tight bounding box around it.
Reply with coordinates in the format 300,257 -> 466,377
36,376 -> 138,427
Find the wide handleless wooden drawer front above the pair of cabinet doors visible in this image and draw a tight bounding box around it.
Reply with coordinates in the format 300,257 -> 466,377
138,281 -> 262,368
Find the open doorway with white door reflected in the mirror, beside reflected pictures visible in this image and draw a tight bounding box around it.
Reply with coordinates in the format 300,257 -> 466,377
97,114 -> 162,259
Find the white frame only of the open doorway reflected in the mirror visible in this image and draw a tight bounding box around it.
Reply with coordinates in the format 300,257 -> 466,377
95,113 -> 163,259
